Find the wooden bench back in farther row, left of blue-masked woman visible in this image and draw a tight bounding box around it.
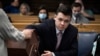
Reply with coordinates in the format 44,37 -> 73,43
8,14 -> 39,23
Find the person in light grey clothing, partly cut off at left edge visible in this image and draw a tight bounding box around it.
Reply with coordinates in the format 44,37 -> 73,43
0,8 -> 29,56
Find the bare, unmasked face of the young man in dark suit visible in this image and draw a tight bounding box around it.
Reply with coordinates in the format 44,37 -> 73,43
54,12 -> 71,30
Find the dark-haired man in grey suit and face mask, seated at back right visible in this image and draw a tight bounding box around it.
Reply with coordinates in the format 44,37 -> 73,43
71,2 -> 89,23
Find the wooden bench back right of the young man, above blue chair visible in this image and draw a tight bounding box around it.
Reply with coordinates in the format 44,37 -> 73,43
73,24 -> 100,33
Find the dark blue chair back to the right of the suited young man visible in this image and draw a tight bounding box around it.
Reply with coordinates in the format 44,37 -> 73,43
78,32 -> 98,56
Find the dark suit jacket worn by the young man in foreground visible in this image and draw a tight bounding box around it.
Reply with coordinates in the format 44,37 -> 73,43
26,19 -> 78,56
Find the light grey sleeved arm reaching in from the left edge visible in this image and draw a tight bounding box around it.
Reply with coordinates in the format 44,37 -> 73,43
0,9 -> 25,40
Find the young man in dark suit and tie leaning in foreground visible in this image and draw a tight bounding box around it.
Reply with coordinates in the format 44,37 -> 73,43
23,6 -> 78,56
